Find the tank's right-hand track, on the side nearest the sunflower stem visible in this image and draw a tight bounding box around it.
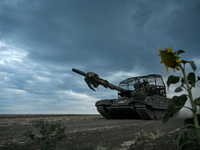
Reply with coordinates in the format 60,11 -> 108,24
135,103 -> 165,120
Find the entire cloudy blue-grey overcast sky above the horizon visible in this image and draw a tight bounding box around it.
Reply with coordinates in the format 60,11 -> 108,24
0,0 -> 200,114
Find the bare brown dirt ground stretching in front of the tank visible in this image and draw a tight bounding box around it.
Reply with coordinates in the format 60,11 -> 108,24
0,115 -> 189,150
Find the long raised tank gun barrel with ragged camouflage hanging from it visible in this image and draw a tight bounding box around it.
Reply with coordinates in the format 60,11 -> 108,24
72,68 -> 129,92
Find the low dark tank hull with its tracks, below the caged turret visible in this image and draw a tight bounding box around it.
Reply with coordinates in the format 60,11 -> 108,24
95,96 -> 171,120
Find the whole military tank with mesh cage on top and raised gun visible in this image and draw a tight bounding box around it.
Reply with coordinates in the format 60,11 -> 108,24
72,68 -> 172,120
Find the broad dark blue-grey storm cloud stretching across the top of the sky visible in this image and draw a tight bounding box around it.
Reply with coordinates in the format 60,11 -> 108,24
2,1 -> 199,67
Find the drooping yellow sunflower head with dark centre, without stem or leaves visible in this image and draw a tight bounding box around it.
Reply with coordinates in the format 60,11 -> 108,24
158,47 -> 181,72
